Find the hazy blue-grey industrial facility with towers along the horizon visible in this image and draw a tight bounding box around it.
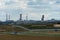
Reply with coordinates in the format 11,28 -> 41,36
0,14 -> 60,24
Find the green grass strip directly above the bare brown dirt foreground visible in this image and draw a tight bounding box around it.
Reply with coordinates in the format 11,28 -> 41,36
0,31 -> 60,36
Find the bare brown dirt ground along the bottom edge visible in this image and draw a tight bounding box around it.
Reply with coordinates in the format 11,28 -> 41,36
0,35 -> 60,40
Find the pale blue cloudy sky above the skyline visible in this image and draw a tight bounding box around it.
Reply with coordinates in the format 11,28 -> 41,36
0,0 -> 60,21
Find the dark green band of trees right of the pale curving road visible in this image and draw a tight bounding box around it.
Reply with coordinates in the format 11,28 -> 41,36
21,24 -> 60,29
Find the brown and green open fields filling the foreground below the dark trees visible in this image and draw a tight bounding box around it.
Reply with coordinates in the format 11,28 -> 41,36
0,25 -> 60,40
